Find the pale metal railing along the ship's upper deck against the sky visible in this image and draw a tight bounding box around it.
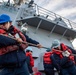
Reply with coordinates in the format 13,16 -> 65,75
34,4 -> 76,30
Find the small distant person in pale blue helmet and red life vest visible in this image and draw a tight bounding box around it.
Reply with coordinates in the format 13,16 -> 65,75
25,47 -> 34,75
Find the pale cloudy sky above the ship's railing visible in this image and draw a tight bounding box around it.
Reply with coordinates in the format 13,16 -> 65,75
1,0 -> 76,48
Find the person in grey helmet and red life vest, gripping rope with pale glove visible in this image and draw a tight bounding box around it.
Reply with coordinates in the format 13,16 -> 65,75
52,40 -> 76,75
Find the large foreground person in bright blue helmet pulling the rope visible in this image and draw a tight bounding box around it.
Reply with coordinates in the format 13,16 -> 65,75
0,14 -> 42,75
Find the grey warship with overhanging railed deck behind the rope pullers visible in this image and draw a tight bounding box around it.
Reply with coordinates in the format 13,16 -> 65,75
0,0 -> 76,75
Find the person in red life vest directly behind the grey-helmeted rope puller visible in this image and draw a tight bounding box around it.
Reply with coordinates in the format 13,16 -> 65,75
43,50 -> 60,75
